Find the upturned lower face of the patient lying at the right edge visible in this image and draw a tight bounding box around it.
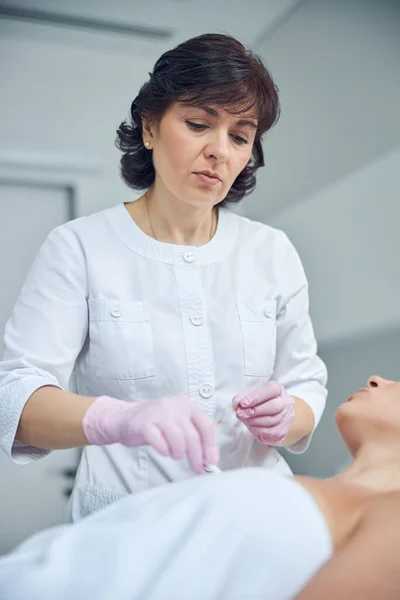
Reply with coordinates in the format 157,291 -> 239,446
335,376 -> 400,456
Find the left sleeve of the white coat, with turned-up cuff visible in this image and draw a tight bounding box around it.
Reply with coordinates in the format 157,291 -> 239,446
0,224 -> 88,464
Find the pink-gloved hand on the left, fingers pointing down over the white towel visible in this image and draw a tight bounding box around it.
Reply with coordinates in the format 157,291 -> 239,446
82,394 -> 219,475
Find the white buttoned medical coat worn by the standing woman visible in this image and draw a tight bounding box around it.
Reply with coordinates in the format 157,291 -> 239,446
0,204 -> 326,520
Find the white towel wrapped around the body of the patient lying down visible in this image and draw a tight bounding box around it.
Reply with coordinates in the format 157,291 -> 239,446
0,469 -> 332,600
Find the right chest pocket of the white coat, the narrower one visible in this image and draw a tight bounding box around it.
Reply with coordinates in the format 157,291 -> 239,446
237,300 -> 276,378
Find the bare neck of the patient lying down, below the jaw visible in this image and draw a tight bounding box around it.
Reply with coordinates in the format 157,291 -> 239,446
335,441 -> 400,496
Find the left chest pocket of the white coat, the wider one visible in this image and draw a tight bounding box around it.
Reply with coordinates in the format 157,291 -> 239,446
89,298 -> 155,379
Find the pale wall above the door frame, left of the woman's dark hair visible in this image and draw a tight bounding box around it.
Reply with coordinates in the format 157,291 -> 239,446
0,36 -> 152,214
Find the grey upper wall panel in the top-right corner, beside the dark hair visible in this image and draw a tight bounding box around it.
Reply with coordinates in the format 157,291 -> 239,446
249,0 -> 400,218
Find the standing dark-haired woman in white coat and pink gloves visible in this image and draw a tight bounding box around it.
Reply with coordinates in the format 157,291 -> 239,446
0,34 -> 326,519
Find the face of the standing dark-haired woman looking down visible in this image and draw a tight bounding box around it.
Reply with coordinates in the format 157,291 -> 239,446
143,102 -> 257,207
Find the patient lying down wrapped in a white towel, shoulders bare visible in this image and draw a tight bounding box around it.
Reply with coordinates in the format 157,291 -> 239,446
0,377 -> 400,600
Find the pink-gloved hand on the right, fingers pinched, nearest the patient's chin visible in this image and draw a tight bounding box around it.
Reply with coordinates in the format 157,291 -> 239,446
232,381 -> 294,446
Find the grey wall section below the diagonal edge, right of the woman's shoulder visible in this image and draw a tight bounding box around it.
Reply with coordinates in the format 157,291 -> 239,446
268,149 -> 400,344
